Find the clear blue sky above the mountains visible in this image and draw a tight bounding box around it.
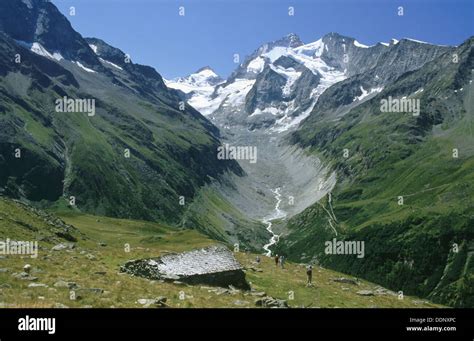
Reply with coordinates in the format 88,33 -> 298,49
52,0 -> 474,78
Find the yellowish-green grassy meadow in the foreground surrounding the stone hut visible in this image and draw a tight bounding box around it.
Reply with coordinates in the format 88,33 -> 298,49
0,203 -> 439,308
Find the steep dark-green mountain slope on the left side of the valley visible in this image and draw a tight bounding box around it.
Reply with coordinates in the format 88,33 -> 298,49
0,0 -> 241,228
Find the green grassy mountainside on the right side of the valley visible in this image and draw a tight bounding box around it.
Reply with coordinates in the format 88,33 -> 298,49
277,37 -> 474,307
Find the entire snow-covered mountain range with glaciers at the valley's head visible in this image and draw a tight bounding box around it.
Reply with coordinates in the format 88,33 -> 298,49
172,33 -> 446,132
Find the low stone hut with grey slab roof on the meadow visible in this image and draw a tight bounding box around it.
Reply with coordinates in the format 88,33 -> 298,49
120,246 -> 250,290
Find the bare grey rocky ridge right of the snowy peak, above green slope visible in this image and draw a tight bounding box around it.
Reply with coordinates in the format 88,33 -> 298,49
313,33 -> 452,118
